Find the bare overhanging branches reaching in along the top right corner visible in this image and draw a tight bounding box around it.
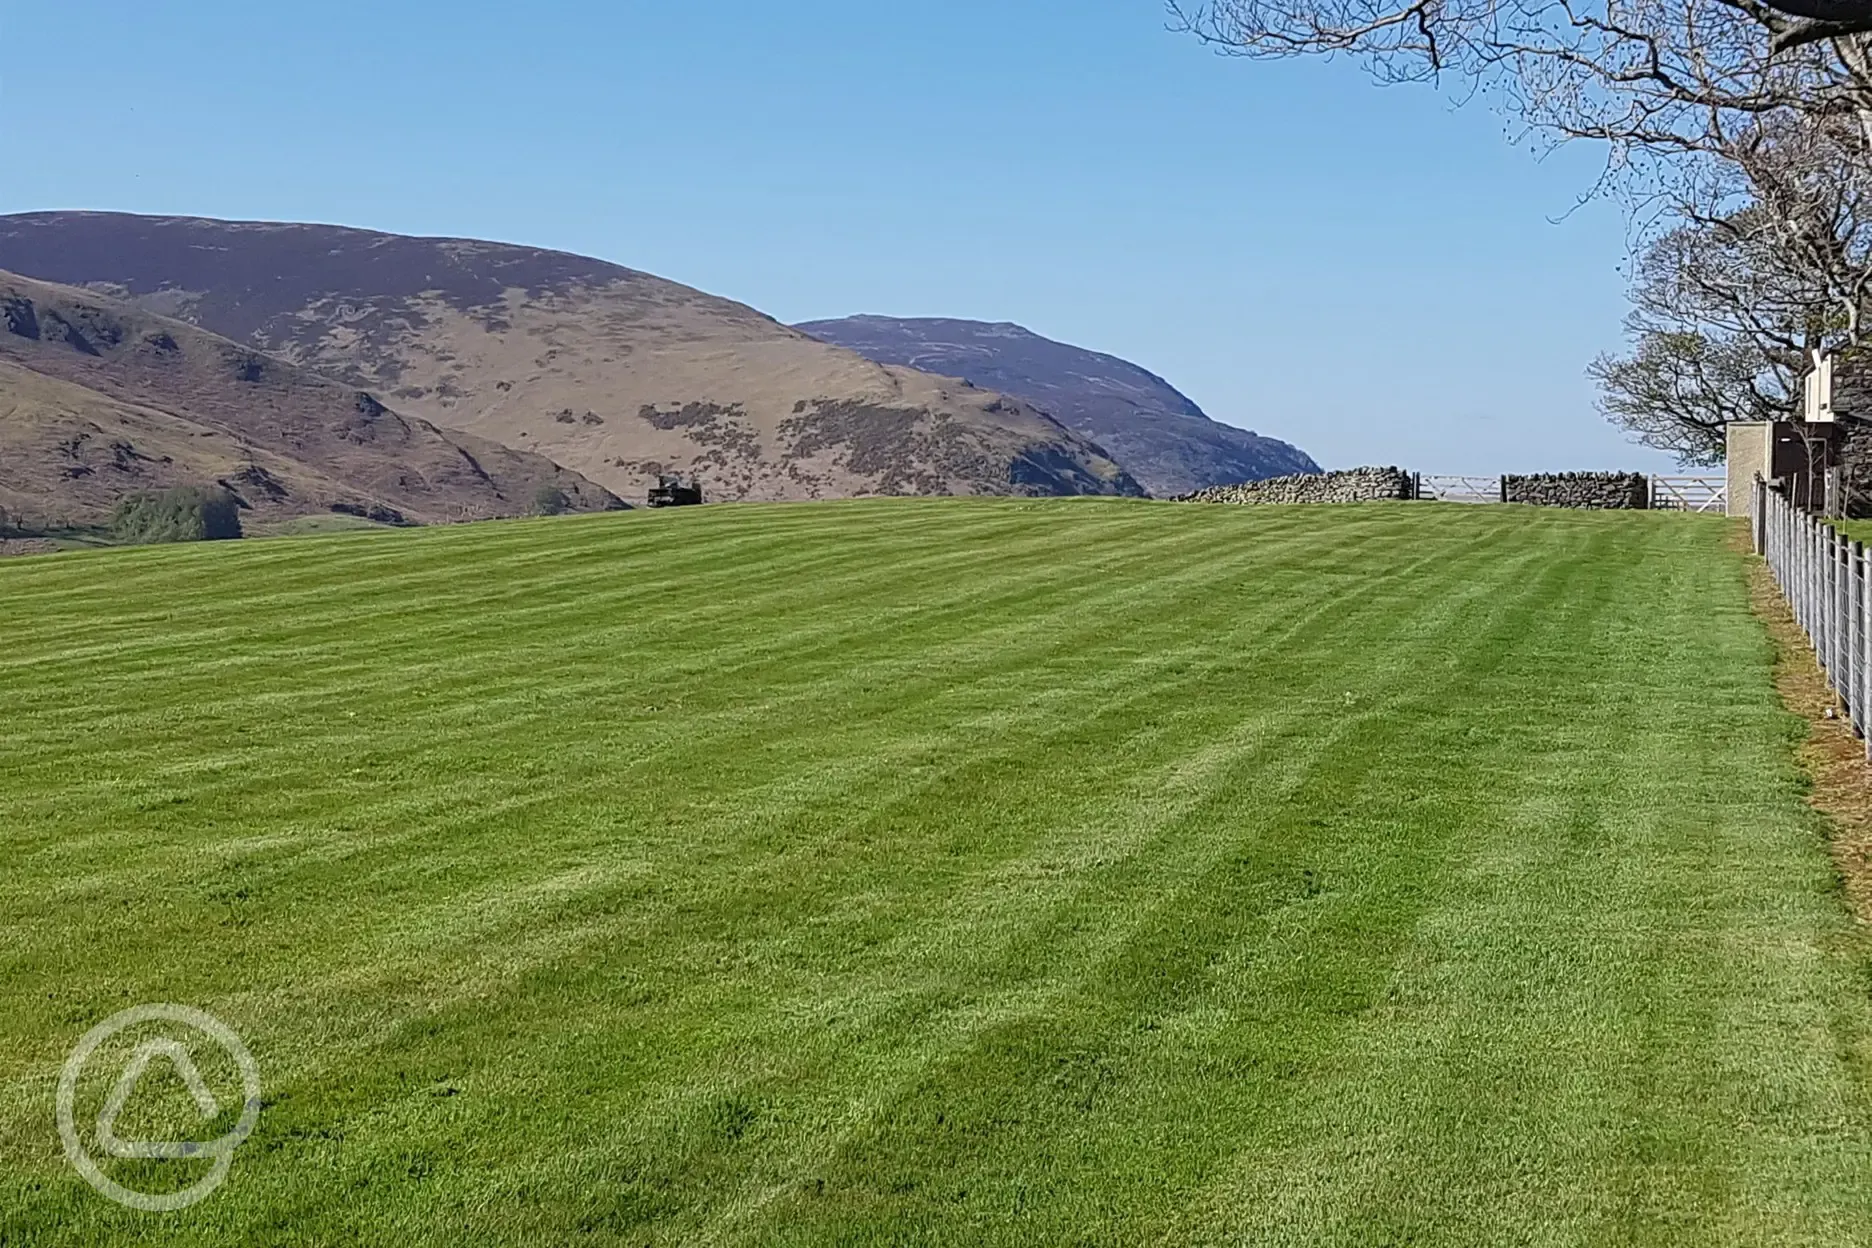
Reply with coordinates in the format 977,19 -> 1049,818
1168,0 -> 1872,232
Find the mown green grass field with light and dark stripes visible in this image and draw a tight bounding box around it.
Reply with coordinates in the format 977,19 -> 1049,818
0,500 -> 1872,1248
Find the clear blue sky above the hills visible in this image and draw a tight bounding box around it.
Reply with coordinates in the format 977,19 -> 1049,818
0,0 -> 1670,473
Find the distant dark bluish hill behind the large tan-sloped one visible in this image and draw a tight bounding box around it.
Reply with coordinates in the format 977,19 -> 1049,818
796,316 -> 1320,498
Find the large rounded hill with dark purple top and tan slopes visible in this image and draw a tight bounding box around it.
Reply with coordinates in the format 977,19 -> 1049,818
0,213 -> 1142,500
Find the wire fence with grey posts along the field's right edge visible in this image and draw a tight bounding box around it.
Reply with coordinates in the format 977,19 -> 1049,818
1750,477 -> 1872,760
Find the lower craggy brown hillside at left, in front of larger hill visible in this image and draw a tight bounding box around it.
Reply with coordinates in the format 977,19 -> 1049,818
0,271 -> 620,526
